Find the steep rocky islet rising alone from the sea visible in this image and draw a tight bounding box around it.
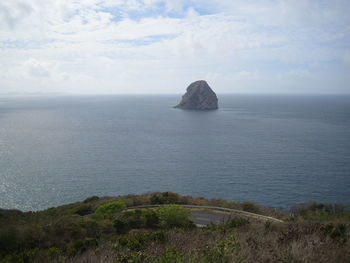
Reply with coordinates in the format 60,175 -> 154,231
175,80 -> 218,110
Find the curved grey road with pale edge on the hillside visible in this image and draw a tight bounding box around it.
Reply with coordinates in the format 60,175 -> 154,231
126,205 -> 283,226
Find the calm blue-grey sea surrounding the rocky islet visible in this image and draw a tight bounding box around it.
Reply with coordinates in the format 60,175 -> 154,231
0,95 -> 350,211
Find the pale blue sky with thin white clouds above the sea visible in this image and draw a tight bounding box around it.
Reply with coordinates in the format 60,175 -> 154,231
0,0 -> 350,94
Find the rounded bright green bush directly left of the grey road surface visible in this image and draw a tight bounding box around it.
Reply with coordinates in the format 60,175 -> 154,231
158,205 -> 193,228
